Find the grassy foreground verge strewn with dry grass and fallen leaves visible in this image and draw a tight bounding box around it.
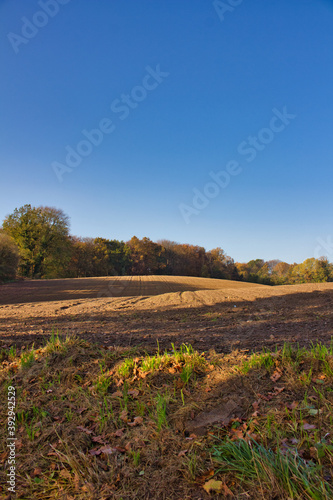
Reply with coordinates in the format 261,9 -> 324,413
0,335 -> 333,500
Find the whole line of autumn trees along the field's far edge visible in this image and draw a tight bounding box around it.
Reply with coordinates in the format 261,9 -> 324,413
0,205 -> 333,285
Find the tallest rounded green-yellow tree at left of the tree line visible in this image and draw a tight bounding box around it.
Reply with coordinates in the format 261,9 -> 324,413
3,205 -> 70,278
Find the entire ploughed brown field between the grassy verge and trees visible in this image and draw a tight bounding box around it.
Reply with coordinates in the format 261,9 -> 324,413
0,276 -> 333,352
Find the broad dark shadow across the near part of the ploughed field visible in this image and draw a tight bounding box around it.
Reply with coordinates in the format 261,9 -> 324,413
0,290 -> 333,353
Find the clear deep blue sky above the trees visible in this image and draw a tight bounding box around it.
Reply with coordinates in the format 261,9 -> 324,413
0,0 -> 333,262
